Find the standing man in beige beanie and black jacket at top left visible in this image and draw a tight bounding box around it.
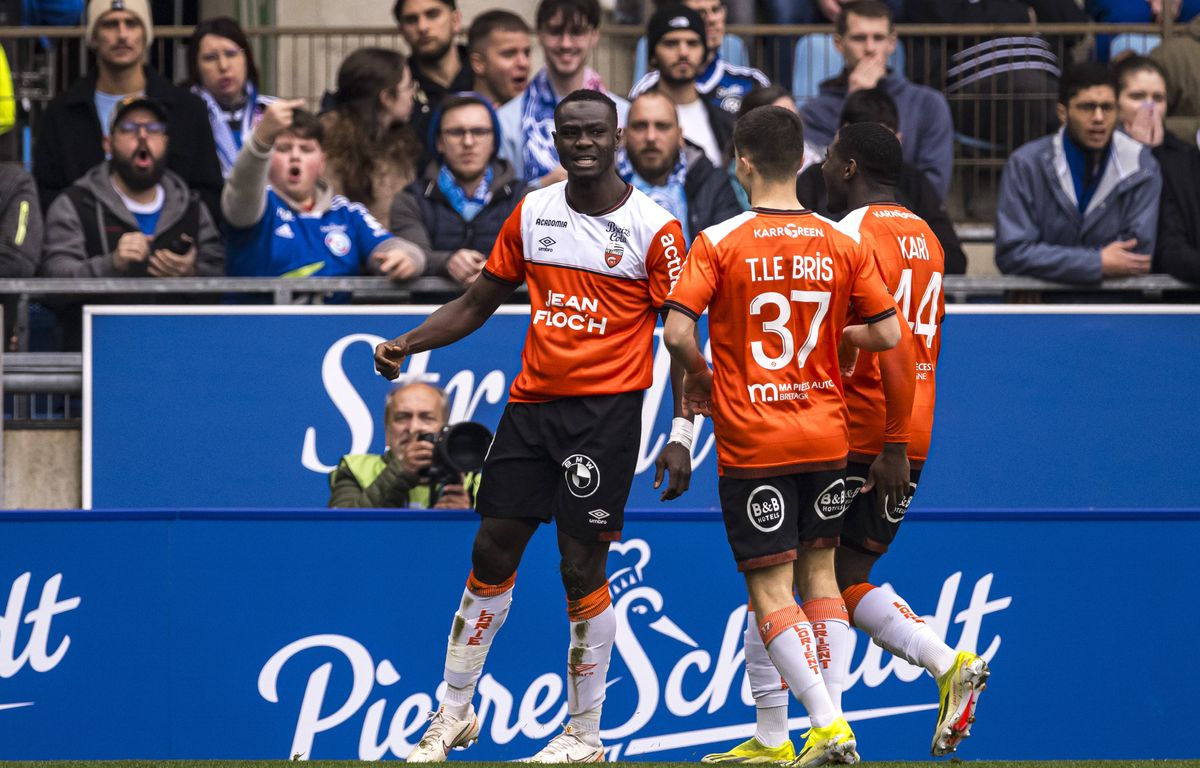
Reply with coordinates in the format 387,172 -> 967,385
34,0 -> 222,222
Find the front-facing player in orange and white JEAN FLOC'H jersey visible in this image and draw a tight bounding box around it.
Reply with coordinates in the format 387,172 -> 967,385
376,90 -> 691,763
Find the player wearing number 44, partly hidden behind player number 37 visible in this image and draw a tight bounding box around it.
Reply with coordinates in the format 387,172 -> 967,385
708,122 -> 989,762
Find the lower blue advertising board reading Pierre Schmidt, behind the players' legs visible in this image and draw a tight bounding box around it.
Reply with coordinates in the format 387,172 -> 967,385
0,510 -> 1200,761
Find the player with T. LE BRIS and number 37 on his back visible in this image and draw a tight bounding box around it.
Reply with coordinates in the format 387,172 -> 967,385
664,107 -> 900,766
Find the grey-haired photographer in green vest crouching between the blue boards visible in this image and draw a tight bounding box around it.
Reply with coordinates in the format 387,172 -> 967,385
329,382 -> 478,509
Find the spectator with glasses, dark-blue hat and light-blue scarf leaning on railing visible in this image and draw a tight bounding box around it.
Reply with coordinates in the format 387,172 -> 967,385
389,94 -> 528,286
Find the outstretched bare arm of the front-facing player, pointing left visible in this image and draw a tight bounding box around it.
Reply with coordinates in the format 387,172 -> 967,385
376,277 -> 516,380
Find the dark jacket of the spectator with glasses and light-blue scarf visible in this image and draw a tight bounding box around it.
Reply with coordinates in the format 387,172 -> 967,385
388,158 -> 529,277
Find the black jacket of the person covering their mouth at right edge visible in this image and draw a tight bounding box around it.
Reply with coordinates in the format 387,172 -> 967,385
1152,133 -> 1200,283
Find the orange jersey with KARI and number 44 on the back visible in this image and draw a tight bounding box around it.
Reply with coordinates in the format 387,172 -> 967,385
841,204 -> 946,461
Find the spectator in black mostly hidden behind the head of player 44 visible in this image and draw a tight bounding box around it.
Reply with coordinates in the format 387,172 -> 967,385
796,88 -> 967,275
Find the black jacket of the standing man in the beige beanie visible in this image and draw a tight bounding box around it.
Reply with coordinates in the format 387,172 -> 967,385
34,67 -> 223,220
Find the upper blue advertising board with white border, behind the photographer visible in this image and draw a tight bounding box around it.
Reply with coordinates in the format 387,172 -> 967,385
84,305 -> 1200,509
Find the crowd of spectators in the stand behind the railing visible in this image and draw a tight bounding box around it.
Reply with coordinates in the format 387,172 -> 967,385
0,0 -> 1200,350
